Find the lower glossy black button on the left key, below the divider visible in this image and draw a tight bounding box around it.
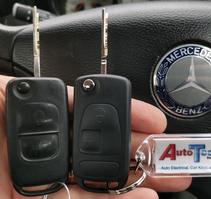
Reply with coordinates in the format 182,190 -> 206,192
20,134 -> 59,161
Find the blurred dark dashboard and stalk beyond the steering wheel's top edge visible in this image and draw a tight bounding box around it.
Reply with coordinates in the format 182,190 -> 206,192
0,0 -> 209,26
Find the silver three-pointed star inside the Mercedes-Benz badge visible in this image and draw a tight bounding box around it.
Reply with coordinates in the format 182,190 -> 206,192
169,57 -> 211,95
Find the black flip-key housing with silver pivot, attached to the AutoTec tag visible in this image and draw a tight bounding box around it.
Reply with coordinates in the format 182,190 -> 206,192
73,74 -> 131,192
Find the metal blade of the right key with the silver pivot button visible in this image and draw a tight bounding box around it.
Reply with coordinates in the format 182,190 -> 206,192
101,8 -> 108,74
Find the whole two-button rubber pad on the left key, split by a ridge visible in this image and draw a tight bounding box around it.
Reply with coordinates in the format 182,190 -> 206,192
16,103 -> 59,161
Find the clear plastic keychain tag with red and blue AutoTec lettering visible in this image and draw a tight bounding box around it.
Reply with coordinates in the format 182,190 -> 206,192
135,134 -> 211,177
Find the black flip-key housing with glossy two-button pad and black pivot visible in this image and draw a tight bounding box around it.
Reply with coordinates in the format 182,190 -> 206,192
6,78 -> 69,196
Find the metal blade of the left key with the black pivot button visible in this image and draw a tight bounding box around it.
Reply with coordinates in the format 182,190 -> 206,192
33,6 -> 40,77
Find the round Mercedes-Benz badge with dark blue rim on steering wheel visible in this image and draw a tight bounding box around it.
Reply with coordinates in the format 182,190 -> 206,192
152,44 -> 211,117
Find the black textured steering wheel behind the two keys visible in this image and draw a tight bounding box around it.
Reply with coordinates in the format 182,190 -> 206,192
0,1 -> 211,198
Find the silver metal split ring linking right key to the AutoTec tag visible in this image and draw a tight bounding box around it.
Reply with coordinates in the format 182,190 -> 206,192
108,162 -> 147,195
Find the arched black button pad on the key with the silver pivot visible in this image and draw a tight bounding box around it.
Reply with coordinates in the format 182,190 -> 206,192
79,104 -> 122,156
